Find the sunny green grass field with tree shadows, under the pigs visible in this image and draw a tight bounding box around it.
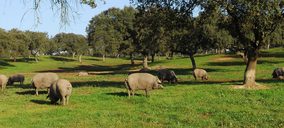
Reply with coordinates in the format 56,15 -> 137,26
0,48 -> 284,128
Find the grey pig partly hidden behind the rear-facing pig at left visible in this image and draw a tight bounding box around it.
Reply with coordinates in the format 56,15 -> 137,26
32,73 -> 58,95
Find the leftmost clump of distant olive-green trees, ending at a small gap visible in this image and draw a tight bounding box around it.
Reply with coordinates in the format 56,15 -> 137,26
0,29 -> 55,61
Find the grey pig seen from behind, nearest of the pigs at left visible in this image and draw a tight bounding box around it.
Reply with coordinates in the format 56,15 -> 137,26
47,79 -> 72,105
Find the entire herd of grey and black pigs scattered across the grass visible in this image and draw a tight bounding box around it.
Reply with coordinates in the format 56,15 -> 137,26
0,67 -> 284,105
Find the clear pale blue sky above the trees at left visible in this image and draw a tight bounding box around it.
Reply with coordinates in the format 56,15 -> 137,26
0,0 -> 130,36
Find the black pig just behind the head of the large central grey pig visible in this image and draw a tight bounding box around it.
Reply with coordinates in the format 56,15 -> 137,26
158,69 -> 177,83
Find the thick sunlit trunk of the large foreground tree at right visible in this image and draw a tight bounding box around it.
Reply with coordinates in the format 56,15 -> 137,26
244,49 -> 258,88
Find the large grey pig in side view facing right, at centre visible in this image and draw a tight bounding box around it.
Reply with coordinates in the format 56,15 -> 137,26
125,73 -> 163,97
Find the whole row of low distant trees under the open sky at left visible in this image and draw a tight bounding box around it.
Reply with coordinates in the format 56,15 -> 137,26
0,29 -> 89,62
